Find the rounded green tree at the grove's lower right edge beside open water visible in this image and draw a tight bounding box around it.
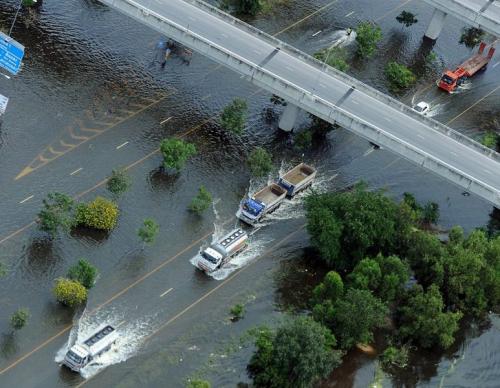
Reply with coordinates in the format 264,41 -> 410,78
397,285 -> 462,349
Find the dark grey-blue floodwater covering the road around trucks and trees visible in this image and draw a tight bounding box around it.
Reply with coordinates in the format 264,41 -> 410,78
0,0 -> 500,387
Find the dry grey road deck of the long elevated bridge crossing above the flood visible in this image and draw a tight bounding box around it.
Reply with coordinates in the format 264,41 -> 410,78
101,0 -> 500,207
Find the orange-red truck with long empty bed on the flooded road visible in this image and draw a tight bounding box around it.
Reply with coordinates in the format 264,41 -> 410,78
438,42 -> 495,92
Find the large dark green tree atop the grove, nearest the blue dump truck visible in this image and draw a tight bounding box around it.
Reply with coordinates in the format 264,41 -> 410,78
306,184 -> 412,271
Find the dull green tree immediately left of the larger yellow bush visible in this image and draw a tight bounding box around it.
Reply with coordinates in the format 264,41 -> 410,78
38,192 -> 74,238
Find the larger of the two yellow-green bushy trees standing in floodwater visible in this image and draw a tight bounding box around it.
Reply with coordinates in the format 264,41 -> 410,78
75,197 -> 120,231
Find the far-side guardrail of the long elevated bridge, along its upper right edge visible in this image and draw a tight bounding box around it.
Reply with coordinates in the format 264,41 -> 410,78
183,0 -> 500,162
